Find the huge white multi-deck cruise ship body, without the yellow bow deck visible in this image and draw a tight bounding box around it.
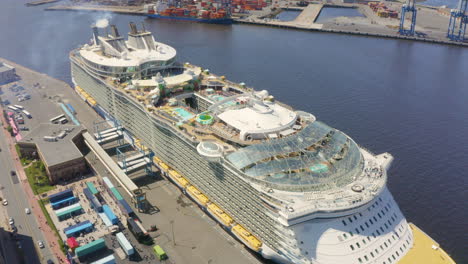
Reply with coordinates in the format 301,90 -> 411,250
70,24 -> 456,264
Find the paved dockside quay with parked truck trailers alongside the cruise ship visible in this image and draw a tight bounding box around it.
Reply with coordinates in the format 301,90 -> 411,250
2,60 -> 260,264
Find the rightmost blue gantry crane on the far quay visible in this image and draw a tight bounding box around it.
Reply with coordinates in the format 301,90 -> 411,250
447,0 -> 468,41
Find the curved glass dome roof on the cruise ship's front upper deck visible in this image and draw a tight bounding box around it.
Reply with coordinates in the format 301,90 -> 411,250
226,121 -> 364,192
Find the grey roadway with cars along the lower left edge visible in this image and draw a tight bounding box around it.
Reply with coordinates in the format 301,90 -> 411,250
0,123 -> 54,264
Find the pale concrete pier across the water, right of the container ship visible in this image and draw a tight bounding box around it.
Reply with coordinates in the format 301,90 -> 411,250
234,2 -> 468,47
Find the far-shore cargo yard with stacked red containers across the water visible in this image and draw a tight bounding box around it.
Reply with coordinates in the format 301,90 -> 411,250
35,0 -> 467,46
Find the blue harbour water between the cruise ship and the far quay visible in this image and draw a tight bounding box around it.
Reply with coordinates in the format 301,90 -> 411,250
0,0 -> 468,263
